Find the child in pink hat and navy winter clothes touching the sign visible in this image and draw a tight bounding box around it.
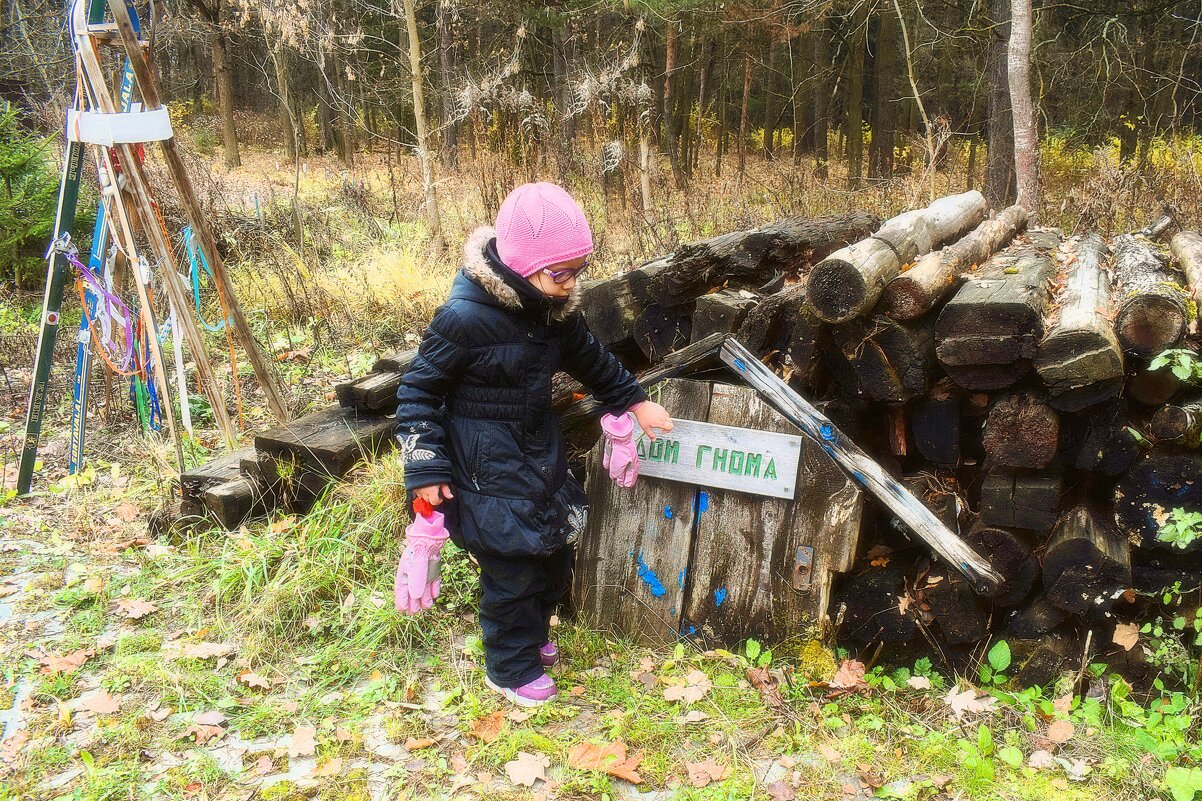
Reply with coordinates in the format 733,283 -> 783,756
397,183 -> 672,706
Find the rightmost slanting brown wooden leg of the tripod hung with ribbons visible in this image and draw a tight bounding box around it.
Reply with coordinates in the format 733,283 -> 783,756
108,0 -> 290,422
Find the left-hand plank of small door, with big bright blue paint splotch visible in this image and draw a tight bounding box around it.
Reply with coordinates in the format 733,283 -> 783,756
572,381 -> 710,645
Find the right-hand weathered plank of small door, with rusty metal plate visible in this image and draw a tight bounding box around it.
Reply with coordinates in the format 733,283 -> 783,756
680,385 -> 862,645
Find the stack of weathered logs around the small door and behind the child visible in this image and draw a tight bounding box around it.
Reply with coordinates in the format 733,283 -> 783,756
171,191 -> 1202,682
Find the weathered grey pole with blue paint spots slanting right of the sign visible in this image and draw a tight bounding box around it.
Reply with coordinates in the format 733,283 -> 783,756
721,337 -> 1002,595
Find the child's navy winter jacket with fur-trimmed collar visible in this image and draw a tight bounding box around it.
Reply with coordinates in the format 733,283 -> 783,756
397,229 -> 647,557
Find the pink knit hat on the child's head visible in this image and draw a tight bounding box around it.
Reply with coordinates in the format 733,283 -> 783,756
496,182 -> 593,278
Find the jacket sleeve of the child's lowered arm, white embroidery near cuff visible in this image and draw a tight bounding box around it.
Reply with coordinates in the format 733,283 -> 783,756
397,307 -> 468,490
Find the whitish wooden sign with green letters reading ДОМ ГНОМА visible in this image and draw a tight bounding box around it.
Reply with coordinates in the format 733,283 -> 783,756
637,420 -> 802,499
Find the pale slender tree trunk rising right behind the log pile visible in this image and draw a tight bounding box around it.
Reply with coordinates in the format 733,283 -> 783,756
1006,0 -> 1043,213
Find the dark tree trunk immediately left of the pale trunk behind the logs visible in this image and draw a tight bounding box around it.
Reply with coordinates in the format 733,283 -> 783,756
984,0 -> 1014,208
